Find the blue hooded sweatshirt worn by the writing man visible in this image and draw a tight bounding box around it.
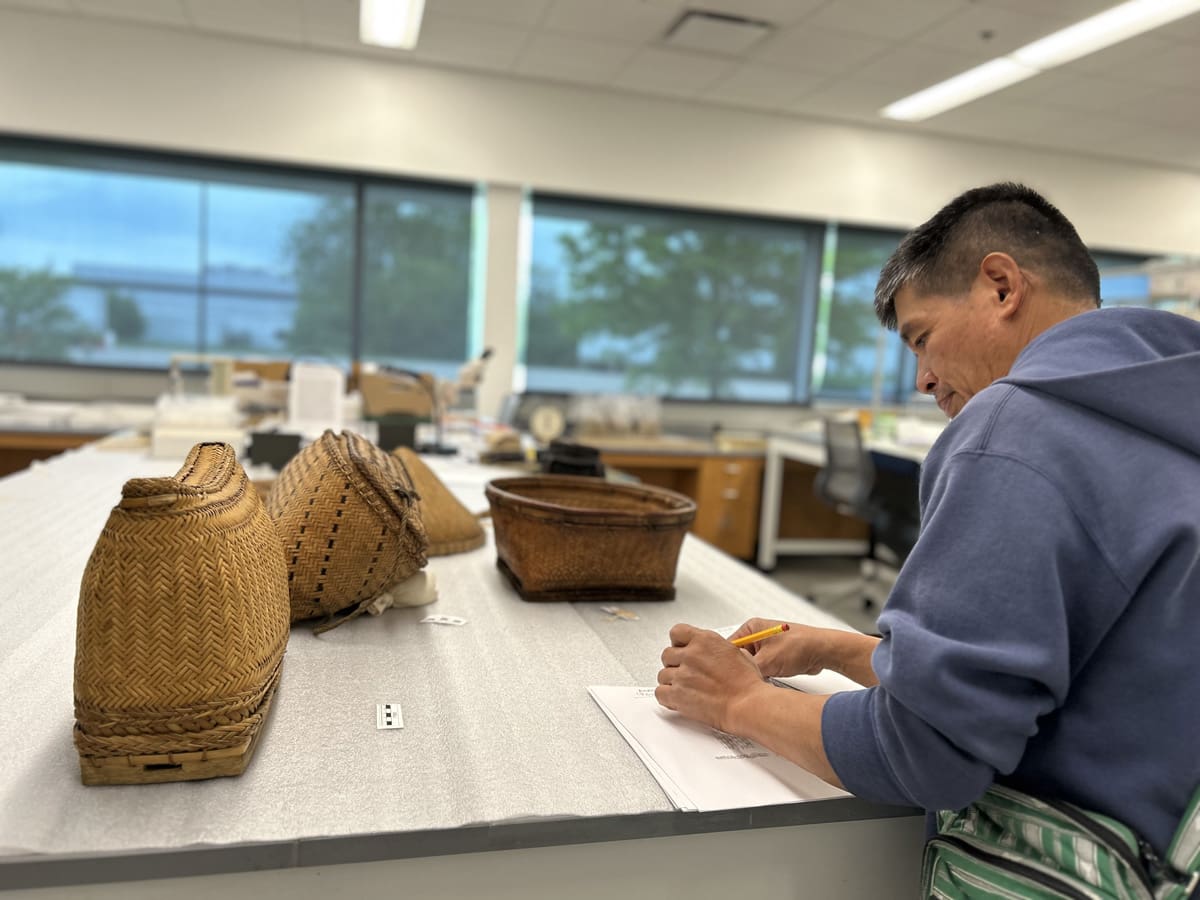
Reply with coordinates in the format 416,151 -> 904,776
822,308 -> 1200,853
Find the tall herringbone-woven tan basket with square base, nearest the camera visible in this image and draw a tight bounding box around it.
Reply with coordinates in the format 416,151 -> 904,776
74,444 -> 288,785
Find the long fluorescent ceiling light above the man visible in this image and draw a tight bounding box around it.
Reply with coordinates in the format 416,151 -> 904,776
880,0 -> 1200,122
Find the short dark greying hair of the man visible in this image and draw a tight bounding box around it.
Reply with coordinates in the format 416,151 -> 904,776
875,181 -> 1100,330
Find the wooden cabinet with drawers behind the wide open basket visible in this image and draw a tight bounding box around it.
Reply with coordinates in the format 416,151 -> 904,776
601,450 -> 762,559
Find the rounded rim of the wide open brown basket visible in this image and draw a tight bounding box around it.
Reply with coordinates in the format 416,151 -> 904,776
484,475 -> 696,524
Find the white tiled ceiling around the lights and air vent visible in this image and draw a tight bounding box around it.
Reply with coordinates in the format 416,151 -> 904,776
0,0 -> 1200,169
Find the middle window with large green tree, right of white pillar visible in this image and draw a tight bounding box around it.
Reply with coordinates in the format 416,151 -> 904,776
522,196 -> 821,403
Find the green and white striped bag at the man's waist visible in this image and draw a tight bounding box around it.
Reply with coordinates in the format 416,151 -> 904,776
923,785 -> 1200,900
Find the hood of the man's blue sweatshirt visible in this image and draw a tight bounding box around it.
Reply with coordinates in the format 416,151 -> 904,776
997,308 -> 1200,456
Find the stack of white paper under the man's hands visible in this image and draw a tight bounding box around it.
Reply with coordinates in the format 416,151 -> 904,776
588,682 -> 859,812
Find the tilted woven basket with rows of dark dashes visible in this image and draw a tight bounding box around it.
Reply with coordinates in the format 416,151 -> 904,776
266,431 -> 428,634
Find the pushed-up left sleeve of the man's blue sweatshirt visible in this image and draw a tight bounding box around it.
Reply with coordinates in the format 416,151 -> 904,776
822,451 -> 1112,810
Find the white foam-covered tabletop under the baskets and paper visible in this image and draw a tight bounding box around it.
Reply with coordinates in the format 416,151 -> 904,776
0,445 -> 911,887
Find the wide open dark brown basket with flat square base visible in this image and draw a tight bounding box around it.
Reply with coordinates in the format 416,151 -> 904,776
486,475 -> 696,600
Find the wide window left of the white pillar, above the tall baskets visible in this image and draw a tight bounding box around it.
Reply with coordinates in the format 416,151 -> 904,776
0,140 -> 472,370
